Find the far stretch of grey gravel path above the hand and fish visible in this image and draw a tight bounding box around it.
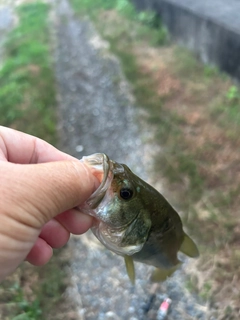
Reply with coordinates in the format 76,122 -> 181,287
52,1 -> 142,172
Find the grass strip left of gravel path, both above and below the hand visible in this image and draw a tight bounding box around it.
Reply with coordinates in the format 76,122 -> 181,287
0,2 -> 66,320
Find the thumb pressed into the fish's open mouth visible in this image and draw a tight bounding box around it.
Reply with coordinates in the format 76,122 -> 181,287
0,161 -> 98,229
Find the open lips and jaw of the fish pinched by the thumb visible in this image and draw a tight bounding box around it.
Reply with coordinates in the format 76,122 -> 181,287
80,153 -> 114,211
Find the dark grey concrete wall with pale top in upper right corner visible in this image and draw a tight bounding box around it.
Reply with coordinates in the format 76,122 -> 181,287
132,0 -> 240,80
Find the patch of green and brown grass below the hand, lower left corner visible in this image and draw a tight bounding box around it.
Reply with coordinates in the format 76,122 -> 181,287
0,251 -> 67,320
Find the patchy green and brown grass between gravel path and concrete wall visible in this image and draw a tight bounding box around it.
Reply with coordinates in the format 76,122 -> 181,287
71,0 -> 240,319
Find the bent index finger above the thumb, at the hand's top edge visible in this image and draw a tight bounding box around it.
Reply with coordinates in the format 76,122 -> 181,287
0,126 -> 76,164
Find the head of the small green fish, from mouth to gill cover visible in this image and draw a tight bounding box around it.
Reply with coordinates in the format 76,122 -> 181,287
79,154 -> 151,255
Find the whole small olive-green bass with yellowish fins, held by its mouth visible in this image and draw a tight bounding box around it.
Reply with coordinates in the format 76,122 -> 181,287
78,153 -> 199,284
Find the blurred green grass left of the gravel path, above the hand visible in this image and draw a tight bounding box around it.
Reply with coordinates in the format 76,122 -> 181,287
0,2 -> 56,143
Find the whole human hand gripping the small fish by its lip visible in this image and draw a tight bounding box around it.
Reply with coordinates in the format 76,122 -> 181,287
0,126 -> 98,280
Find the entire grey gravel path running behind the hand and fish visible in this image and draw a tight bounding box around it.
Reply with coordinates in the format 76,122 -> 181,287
54,0 -> 210,320
